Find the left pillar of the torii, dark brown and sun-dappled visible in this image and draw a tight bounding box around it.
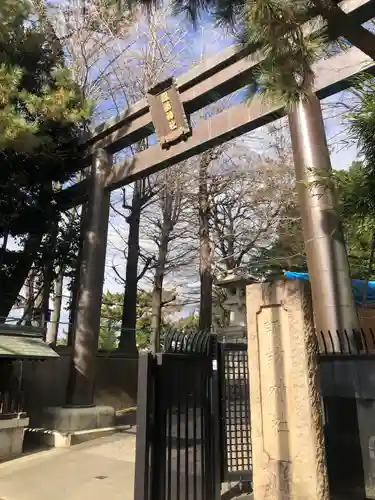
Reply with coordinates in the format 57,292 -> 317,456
67,149 -> 112,406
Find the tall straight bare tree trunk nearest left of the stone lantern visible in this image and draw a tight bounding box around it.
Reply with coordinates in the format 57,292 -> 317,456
198,161 -> 212,332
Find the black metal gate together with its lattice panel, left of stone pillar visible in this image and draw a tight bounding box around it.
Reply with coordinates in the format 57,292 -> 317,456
135,332 -> 252,500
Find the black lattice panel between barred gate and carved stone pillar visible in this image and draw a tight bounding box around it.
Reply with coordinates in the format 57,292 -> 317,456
219,342 -> 252,481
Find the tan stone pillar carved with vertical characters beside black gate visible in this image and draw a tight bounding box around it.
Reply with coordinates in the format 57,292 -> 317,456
246,280 -> 329,500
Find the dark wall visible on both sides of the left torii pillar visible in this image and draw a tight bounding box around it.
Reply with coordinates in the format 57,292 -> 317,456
18,347 -> 138,427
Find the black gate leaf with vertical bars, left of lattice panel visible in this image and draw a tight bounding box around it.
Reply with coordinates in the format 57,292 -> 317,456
135,333 -> 221,500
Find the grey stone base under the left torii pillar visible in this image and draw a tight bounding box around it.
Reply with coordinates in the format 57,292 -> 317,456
26,405 -> 116,448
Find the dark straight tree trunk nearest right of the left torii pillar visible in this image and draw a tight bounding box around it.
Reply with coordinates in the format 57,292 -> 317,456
118,181 -> 142,354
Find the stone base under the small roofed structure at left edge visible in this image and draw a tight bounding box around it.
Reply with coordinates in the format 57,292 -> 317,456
0,417 -> 29,461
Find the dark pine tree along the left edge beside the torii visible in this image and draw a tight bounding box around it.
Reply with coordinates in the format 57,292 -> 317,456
0,0 -> 90,320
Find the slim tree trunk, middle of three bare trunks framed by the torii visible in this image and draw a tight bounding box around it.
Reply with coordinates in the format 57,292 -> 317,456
151,234 -> 169,353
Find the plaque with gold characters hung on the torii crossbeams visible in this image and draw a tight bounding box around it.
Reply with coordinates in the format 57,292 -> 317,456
147,78 -> 190,148
